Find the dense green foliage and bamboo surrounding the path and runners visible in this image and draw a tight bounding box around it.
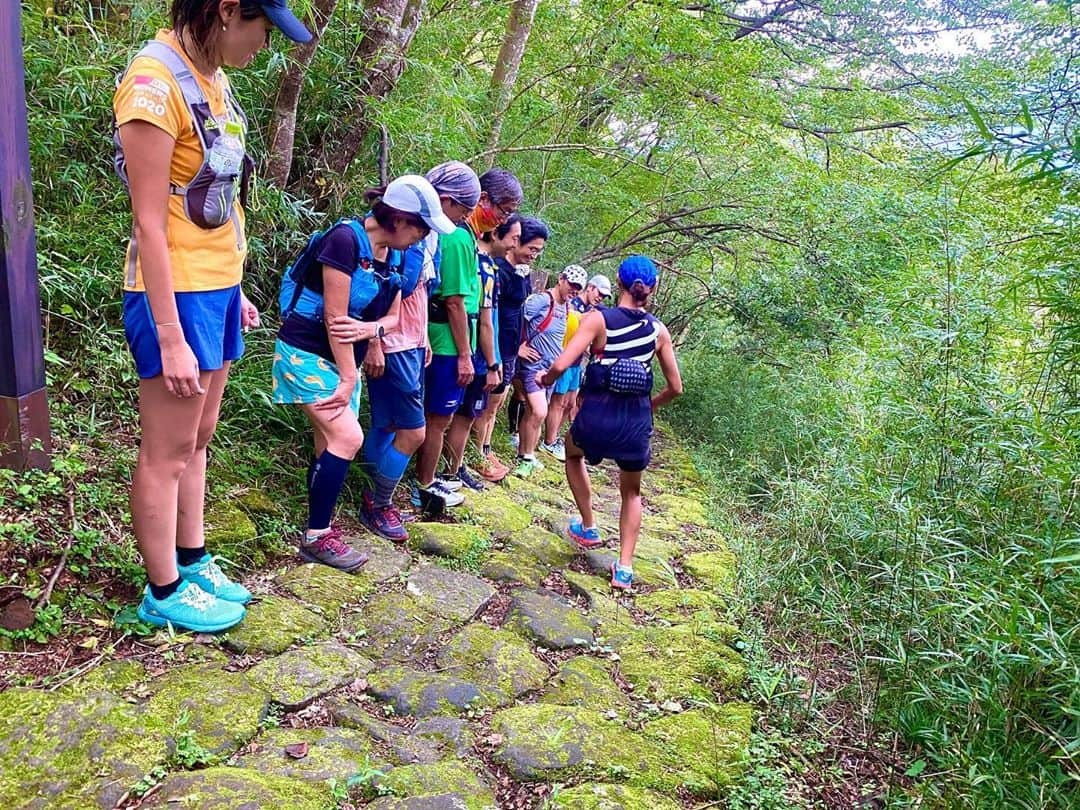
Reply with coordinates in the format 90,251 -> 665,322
8,0 -> 1080,809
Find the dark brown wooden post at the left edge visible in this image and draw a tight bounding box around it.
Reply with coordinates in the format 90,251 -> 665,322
0,0 -> 51,470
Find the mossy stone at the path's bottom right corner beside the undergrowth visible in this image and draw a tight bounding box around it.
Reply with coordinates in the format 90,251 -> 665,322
643,703 -> 753,798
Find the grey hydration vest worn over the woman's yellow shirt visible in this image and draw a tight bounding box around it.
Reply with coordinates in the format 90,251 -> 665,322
112,40 -> 255,234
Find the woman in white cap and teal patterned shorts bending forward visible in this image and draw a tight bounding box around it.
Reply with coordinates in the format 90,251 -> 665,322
272,175 -> 455,571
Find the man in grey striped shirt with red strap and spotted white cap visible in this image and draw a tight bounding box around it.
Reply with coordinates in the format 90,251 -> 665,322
514,265 -> 586,478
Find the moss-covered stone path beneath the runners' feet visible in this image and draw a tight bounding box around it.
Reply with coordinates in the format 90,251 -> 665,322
0,429 -> 753,810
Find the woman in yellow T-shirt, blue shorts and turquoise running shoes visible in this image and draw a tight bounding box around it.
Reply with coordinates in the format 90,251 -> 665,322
112,0 -> 311,633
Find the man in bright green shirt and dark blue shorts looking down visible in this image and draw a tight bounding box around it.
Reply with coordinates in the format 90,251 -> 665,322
416,167 -> 523,509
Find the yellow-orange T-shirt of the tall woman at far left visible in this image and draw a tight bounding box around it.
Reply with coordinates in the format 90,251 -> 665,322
112,30 -> 247,293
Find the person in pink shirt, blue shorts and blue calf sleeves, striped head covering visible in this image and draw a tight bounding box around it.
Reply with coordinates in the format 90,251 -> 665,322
360,161 -> 481,535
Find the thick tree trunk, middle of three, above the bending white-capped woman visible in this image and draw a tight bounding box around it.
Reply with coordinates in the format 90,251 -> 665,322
321,0 -> 424,185
